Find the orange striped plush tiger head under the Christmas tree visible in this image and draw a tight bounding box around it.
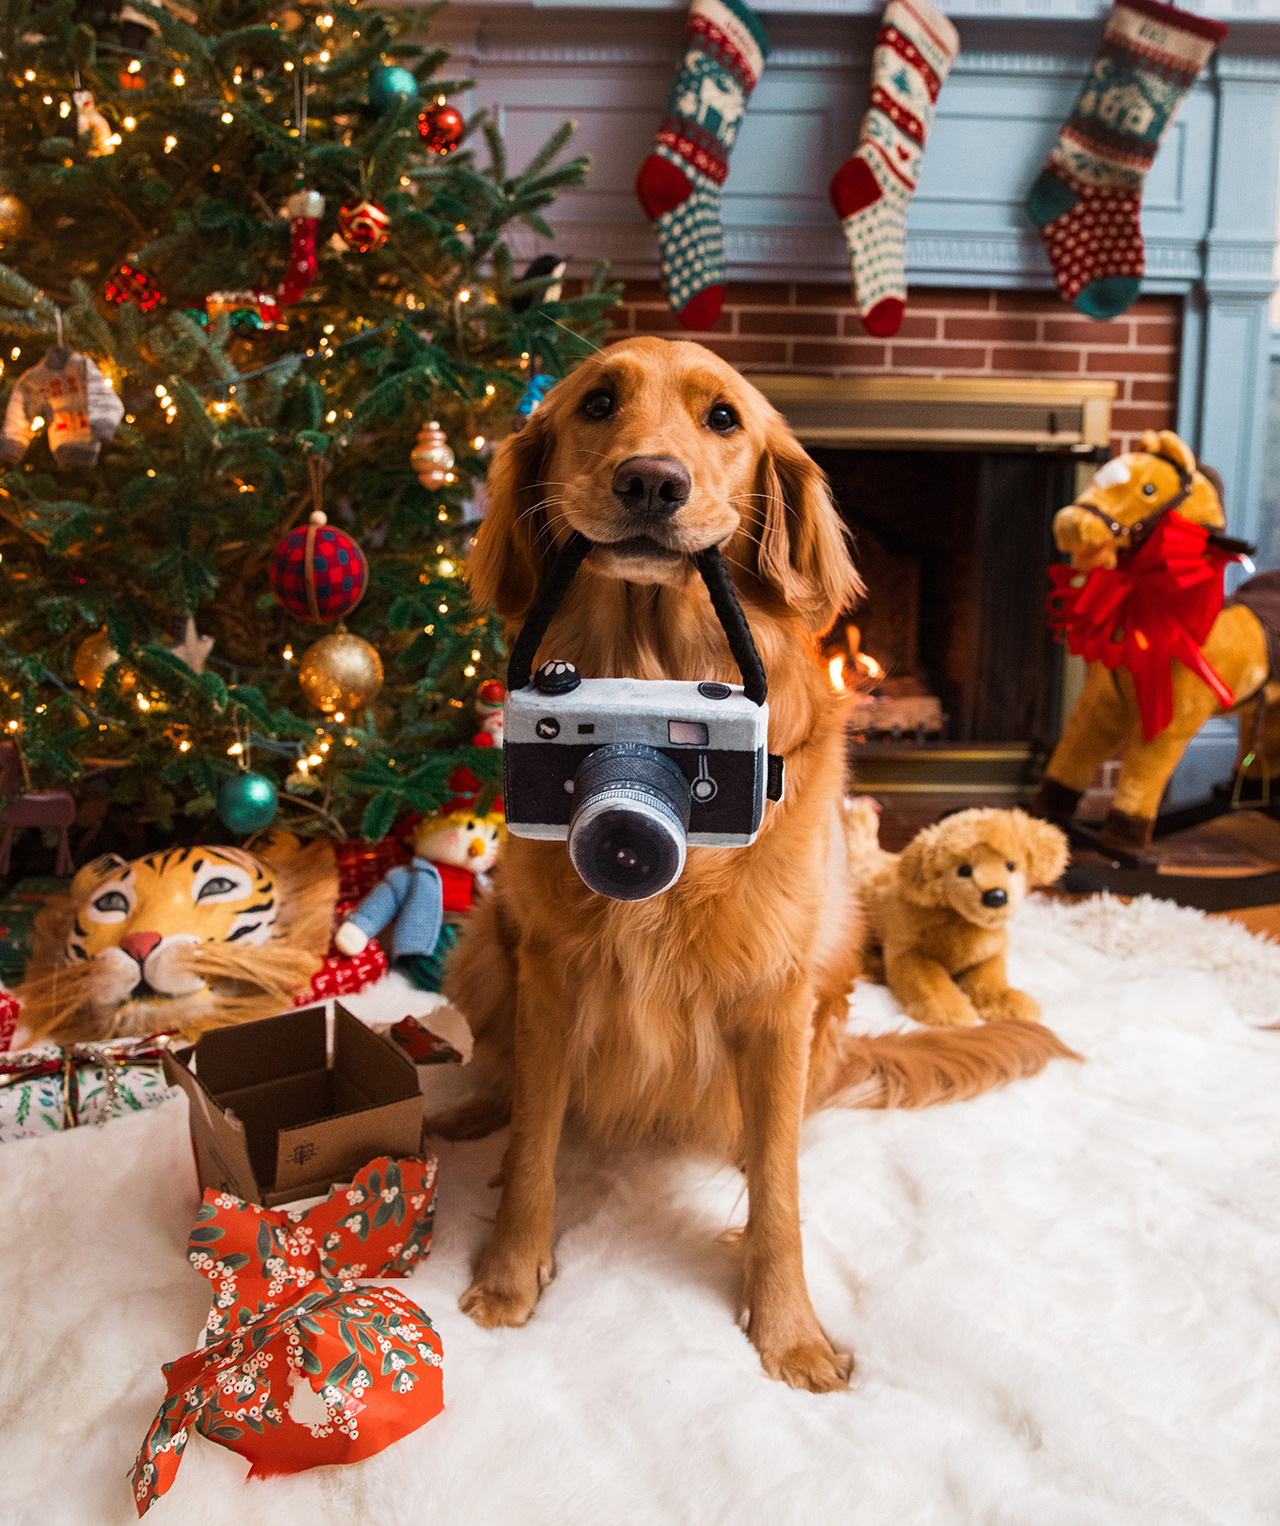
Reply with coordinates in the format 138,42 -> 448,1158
15,832 -> 337,1044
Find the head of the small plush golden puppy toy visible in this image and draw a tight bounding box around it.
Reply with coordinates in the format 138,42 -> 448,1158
899,810 -> 1066,928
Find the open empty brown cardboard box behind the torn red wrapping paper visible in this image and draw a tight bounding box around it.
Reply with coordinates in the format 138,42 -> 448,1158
163,1003 -> 423,1209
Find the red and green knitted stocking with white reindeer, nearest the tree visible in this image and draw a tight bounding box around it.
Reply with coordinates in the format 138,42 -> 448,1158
636,0 -> 769,328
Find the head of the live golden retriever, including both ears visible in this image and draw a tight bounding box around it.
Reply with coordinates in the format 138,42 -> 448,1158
468,339 -> 860,630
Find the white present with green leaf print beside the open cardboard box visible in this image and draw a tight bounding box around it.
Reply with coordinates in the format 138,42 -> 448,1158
0,1033 -> 177,1143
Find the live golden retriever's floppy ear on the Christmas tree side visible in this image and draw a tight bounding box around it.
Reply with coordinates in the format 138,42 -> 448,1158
467,403 -> 552,620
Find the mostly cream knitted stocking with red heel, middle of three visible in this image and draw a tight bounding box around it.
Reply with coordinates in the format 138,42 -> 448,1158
831,0 -> 960,339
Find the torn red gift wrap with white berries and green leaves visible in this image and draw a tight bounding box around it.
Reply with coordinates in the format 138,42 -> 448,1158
133,1157 -> 444,1515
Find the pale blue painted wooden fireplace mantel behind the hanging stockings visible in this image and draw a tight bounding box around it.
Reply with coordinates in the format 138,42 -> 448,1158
433,0 -> 1280,549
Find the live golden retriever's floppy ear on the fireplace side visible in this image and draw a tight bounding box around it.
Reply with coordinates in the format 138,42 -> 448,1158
757,415 -> 862,630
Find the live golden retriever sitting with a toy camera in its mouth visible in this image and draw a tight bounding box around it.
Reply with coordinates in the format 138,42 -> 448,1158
445,339 -> 1063,1392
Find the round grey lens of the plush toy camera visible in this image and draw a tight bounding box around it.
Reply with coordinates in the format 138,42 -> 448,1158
569,742 -> 690,900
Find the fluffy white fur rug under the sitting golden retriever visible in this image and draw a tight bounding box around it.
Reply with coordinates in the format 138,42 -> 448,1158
0,900 -> 1280,1526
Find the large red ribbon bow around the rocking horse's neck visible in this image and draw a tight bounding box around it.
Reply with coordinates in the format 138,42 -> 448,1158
1048,510 -> 1239,742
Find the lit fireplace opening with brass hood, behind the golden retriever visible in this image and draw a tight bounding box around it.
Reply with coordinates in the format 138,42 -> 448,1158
754,372 -> 1115,755
